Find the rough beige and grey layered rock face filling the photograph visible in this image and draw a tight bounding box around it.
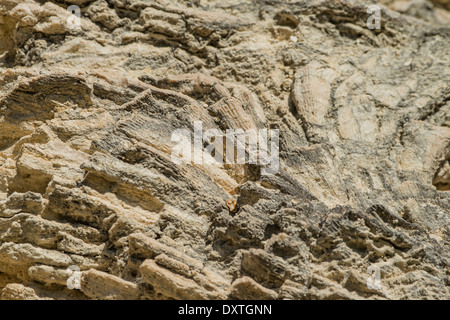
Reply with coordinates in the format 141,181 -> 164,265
0,0 -> 450,299
